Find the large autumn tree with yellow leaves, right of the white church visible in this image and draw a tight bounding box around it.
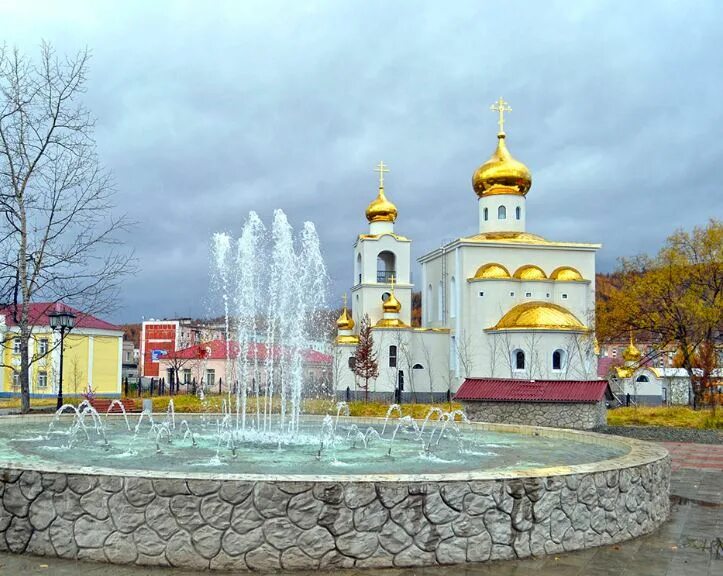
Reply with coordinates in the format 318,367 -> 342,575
597,219 -> 723,405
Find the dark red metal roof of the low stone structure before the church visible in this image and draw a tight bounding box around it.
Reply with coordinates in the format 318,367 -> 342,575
455,378 -> 608,402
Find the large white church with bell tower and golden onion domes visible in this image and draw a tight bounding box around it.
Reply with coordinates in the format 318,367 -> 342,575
334,98 -> 600,401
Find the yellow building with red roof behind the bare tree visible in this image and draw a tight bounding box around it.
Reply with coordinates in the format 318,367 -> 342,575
0,303 -> 123,398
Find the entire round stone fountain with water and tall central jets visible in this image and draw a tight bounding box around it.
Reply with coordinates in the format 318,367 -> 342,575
0,211 -> 670,571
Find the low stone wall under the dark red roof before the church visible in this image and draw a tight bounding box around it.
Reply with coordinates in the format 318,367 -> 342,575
462,402 -> 607,430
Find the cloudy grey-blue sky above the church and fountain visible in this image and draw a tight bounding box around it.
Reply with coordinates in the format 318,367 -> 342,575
0,0 -> 723,322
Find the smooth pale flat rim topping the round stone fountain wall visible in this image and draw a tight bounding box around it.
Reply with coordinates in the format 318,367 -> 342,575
0,413 -> 668,483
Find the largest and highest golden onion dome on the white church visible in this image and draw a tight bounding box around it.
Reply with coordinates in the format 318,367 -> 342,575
472,132 -> 532,198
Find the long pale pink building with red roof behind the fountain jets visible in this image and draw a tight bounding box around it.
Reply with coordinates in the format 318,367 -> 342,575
158,339 -> 332,390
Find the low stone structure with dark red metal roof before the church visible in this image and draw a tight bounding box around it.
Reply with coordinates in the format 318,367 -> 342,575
455,378 -> 612,429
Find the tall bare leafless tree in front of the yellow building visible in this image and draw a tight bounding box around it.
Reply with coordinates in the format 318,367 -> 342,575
0,44 -> 133,412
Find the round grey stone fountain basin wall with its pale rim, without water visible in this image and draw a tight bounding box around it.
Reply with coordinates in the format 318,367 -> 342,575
0,416 -> 670,570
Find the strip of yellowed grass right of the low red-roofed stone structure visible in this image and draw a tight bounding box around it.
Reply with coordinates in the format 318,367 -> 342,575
608,406 -> 723,430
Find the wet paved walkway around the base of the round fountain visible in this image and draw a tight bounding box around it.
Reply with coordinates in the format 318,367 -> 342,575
0,444 -> 723,576
